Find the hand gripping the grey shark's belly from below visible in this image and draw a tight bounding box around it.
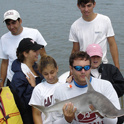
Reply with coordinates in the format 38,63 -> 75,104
63,103 -> 77,123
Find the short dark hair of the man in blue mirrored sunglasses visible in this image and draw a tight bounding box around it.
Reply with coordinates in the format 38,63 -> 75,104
69,51 -> 91,66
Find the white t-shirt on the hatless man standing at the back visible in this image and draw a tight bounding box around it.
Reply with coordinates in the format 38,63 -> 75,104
69,14 -> 114,63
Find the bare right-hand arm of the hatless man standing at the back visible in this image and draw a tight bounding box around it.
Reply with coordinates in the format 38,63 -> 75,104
107,36 -> 120,69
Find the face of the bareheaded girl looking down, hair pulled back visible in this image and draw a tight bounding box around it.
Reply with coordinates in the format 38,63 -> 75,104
42,65 -> 58,84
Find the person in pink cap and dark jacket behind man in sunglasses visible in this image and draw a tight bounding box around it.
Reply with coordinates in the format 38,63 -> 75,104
86,44 -> 124,124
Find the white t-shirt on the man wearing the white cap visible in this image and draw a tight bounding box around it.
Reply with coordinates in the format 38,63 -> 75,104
0,27 -> 47,81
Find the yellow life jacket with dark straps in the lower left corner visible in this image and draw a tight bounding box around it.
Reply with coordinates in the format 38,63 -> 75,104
0,87 -> 23,124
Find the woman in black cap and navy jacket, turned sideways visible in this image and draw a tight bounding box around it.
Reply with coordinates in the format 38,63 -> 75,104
10,38 -> 43,124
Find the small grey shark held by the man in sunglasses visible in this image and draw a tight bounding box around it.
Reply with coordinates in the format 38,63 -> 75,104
32,77 -> 124,119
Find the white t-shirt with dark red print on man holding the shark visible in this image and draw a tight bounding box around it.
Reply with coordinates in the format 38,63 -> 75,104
53,77 -> 120,124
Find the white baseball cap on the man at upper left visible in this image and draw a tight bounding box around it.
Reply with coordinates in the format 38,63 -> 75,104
3,10 -> 20,22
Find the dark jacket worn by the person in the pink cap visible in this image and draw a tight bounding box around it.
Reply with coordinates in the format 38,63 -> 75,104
94,63 -> 124,97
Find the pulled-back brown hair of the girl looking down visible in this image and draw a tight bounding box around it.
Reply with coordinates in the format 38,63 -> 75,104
38,54 -> 57,74
